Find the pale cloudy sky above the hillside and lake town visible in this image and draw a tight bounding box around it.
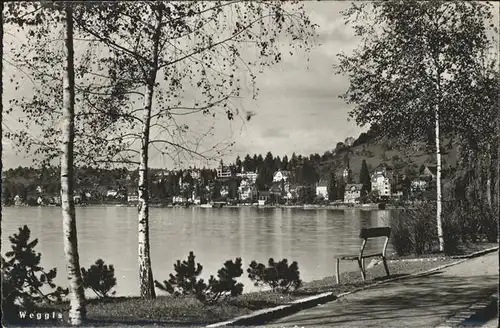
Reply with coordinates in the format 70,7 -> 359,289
2,1 -> 498,168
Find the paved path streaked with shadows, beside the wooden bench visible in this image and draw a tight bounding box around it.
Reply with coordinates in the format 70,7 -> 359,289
266,251 -> 498,327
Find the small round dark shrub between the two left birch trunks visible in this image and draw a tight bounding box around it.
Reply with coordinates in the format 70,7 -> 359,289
81,259 -> 116,298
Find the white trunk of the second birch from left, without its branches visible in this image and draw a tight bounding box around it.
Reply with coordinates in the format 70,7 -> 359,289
138,83 -> 156,299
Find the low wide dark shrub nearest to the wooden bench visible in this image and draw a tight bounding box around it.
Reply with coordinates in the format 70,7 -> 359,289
247,258 -> 302,292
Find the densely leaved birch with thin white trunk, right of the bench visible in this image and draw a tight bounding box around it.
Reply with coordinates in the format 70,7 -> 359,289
336,1 -> 492,251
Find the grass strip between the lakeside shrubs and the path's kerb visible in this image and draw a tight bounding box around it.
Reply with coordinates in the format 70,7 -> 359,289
6,243 -> 497,327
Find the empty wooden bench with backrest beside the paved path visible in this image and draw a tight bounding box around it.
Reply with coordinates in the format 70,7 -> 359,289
335,227 -> 391,284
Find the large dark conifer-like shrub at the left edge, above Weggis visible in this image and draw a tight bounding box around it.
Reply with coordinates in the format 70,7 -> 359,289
1,225 -> 68,309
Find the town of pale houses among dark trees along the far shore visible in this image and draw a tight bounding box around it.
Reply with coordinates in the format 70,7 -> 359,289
2,135 -> 442,207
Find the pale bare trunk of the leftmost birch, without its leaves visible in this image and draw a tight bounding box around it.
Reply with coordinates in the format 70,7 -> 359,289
61,4 -> 86,325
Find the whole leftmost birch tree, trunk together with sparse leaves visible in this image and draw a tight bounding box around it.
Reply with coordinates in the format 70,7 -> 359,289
2,2 -> 128,325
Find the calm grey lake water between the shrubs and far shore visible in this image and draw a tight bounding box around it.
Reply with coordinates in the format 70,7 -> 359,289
2,206 -> 391,295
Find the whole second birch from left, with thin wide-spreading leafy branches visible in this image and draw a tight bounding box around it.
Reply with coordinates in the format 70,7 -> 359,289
75,1 -> 315,298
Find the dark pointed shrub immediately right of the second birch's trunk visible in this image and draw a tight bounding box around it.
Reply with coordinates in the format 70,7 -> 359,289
155,251 -> 206,295
